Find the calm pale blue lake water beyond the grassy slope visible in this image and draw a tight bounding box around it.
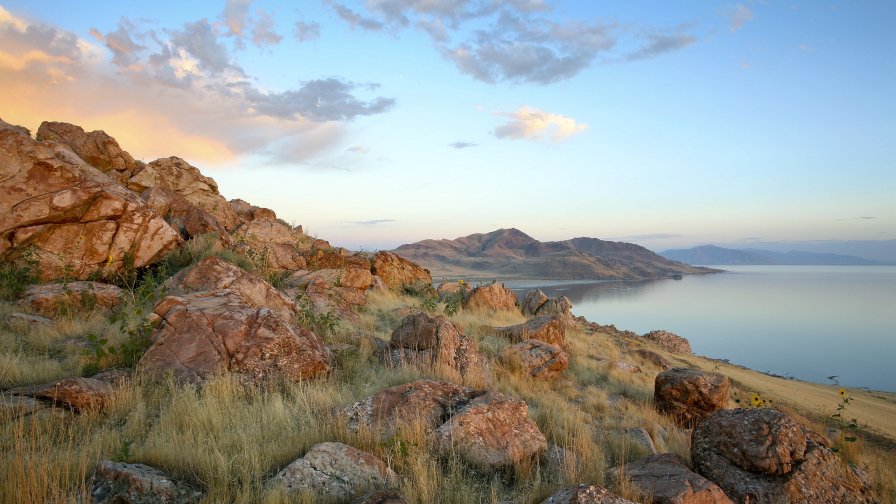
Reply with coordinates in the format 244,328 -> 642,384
507,266 -> 896,391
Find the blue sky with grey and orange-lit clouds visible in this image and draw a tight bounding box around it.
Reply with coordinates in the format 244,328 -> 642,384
0,0 -> 896,250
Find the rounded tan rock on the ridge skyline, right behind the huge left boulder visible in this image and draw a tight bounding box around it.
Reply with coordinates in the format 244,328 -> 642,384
128,156 -> 240,231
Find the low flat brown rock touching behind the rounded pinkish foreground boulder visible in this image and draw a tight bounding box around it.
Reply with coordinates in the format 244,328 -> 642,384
343,380 -> 482,439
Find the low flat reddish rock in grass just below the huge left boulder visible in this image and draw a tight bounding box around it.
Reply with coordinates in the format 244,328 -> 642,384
19,282 -> 124,317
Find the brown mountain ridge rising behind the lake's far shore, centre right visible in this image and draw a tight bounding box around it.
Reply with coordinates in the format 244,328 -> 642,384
395,229 -> 716,280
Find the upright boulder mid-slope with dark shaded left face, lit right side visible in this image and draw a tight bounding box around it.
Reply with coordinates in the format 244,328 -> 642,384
388,312 -> 485,382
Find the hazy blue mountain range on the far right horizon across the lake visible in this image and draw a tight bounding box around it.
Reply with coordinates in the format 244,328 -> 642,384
660,245 -> 885,266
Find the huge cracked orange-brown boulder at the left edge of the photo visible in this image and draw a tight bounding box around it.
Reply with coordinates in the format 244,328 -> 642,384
0,123 -> 181,281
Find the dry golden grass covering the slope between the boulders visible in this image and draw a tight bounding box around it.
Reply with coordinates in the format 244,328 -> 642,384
0,258 -> 896,503
